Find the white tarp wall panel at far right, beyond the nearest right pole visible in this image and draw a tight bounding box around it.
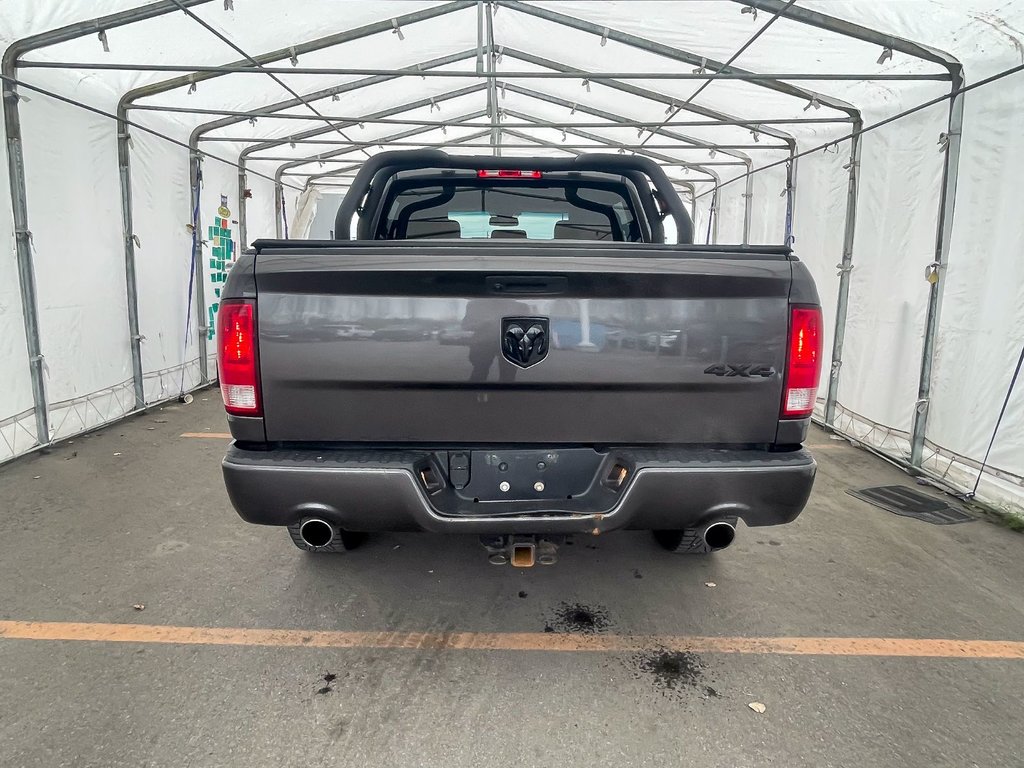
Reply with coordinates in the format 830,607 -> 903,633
926,81 -> 1024,508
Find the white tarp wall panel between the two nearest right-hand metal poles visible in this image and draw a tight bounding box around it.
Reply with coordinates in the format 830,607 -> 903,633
827,104 -> 947,451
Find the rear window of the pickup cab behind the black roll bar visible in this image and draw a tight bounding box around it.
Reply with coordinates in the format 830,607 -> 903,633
377,179 -> 643,243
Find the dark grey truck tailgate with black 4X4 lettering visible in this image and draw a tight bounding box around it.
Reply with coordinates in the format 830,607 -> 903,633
255,242 -> 792,445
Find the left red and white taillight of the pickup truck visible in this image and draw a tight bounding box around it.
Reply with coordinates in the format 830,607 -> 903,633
217,300 -> 263,416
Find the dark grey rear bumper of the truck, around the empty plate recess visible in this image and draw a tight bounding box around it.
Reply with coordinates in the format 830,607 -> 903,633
223,444 -> 816,535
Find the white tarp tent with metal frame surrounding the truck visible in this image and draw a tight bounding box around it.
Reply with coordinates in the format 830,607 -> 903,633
0,0 -> 1024,520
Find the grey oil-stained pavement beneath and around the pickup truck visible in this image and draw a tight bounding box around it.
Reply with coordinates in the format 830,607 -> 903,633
0,390 -> 1024,768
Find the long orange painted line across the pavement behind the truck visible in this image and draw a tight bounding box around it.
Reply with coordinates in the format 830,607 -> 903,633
0,622 -> 1024,660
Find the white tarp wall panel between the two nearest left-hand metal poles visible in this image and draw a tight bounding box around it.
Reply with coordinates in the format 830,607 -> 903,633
20,78 -> 135,440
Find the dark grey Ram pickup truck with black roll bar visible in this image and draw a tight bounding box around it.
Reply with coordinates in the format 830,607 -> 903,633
217,151 -> 821,566
